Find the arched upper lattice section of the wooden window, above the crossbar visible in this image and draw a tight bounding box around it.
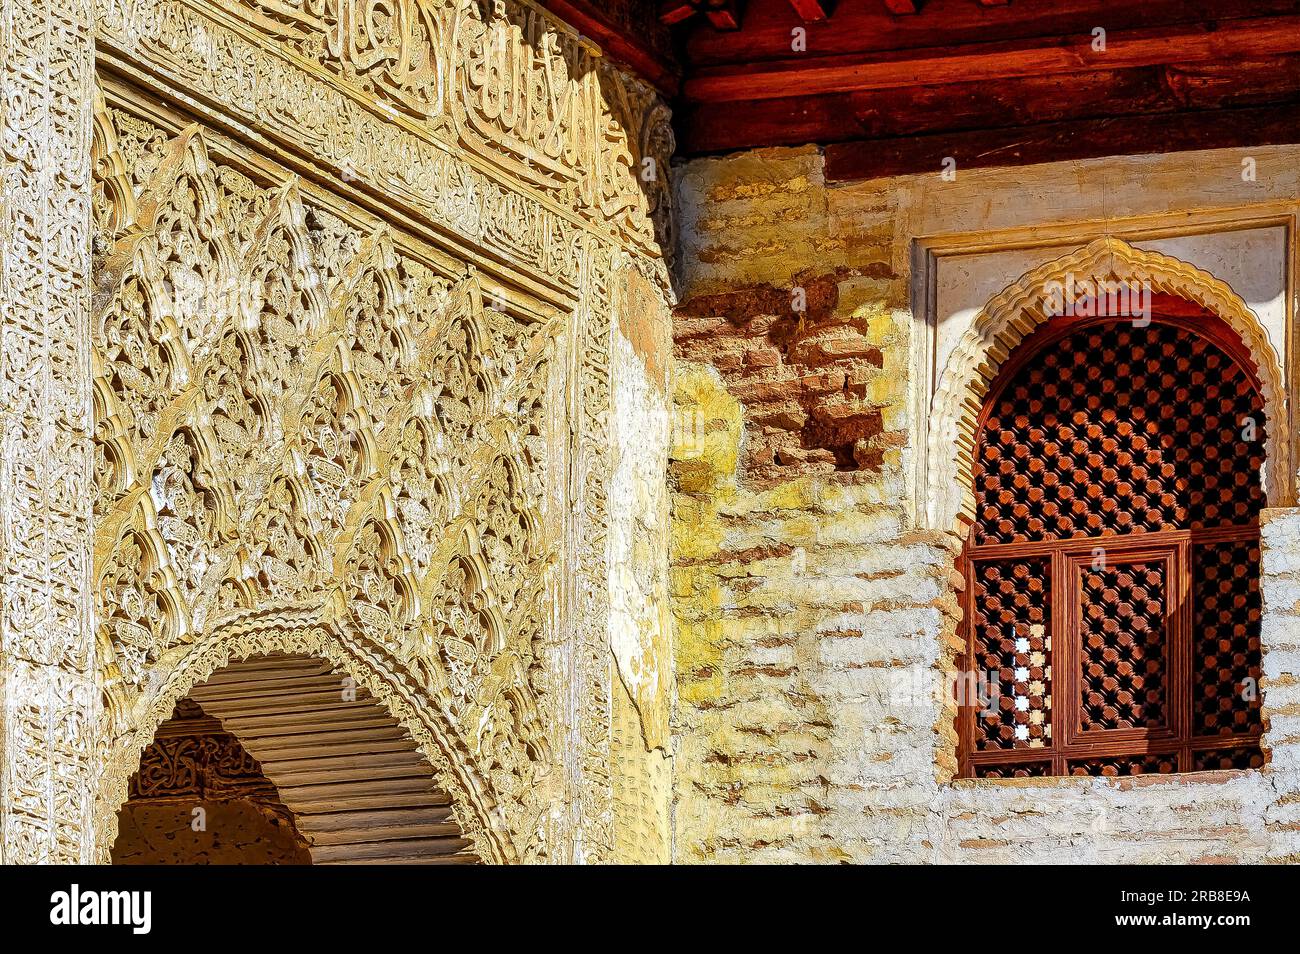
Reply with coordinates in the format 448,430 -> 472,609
975,321 -> 1265,545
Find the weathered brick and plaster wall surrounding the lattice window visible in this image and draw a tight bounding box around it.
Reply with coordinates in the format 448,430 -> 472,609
671,147 -> 1300,863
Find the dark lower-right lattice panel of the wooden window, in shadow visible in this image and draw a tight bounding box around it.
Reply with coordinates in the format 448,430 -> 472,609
1192,539 -> 1261,736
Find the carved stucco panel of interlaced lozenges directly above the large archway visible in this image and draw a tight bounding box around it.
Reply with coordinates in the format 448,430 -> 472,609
92,113 -> 568,860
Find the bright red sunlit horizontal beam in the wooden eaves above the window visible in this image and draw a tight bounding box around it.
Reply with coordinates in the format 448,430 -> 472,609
684,16 -> 1300,103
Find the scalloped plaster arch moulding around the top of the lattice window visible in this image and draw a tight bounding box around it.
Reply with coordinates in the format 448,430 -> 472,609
927,237 -> 1292,533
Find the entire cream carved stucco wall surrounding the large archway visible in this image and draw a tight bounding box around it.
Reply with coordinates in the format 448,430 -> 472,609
0,0 -> 672,862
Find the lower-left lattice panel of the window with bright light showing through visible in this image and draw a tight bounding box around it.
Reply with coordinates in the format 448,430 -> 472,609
974,560 -> 1052,749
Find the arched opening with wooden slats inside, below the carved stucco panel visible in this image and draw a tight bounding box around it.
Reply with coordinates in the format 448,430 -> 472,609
112,654 -> 478,864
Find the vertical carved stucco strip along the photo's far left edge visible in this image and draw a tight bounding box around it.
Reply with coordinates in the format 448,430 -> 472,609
0,0 -> 98,864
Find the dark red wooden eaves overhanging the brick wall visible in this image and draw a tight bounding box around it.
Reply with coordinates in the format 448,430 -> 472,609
547,0 -> 1300,178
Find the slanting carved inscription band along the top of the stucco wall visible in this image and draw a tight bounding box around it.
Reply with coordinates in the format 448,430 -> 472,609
96,0 -> 673,282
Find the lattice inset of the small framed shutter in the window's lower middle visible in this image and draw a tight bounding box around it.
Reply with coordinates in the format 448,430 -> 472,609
1080,560 -> 1167,732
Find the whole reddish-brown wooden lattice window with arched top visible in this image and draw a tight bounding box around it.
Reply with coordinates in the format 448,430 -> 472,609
958,296 -> 1266,779
